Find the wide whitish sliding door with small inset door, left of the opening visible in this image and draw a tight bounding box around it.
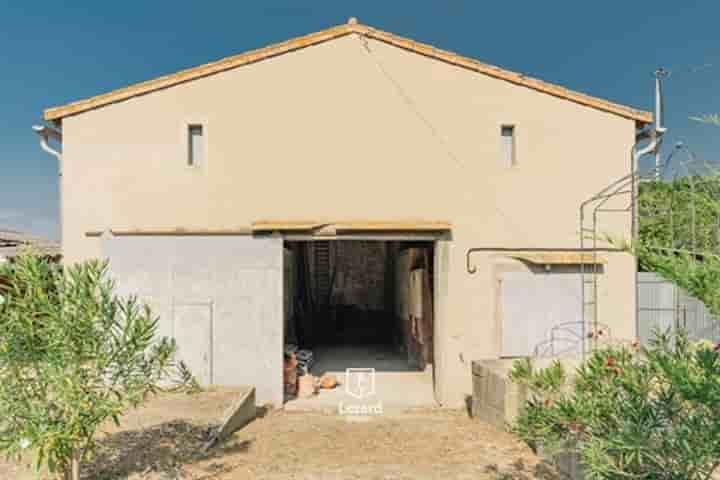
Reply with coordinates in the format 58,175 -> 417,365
103,236 -> 283,405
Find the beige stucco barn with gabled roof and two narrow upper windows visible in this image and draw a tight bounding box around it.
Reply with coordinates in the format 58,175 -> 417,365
40,21 -> 652,406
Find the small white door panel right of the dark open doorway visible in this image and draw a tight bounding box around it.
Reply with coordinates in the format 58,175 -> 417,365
501,272 -> 582,357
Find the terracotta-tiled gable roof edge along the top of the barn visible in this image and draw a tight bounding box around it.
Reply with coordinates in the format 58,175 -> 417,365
44,18 -> 652,125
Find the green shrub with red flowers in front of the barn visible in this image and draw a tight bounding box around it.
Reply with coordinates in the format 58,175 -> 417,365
511,333 -> 720,480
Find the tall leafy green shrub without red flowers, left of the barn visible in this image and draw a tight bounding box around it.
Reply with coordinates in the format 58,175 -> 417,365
0,253 -> 175,480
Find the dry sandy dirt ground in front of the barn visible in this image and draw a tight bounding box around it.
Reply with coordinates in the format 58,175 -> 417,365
0,391 -> 556,480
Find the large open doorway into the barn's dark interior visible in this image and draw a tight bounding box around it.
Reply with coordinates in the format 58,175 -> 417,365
284,240 -> 435,408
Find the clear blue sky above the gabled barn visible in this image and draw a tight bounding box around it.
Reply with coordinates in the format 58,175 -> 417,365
0,0 -> 720,238
